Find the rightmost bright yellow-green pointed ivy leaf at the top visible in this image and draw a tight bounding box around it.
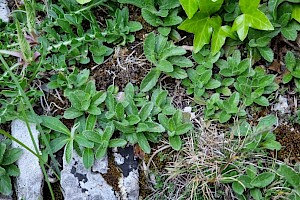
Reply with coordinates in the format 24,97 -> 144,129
232,0 -> 274,41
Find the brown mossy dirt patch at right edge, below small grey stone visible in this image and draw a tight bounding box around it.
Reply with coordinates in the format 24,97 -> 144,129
274,125 -> 300,164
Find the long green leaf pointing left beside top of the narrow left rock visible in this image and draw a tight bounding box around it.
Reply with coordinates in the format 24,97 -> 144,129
41,116 -> 71,136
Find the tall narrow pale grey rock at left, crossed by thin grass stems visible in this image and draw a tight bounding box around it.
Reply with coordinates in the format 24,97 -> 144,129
11,120 -> 43,200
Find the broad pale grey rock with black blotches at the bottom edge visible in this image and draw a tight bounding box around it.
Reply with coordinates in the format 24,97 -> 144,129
60,151 -> 117,200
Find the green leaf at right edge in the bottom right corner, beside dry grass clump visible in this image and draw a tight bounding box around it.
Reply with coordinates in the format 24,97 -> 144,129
278,164 -> 300,191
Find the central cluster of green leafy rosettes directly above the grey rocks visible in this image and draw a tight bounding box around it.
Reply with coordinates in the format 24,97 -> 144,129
42,81 -> 193,168
